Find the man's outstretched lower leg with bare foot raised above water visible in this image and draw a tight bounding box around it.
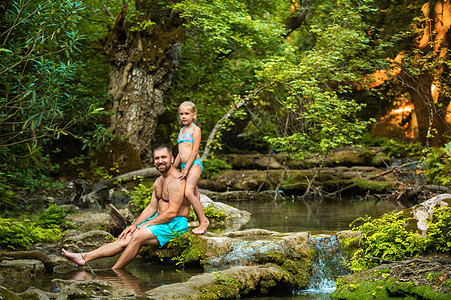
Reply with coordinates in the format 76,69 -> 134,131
62,236 -> 131,266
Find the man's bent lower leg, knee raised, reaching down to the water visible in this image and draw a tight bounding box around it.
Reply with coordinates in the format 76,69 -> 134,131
112,228 -> 160,270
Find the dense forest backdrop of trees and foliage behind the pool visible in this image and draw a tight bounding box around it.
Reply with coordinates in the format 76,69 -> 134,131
0,0 -> 451,213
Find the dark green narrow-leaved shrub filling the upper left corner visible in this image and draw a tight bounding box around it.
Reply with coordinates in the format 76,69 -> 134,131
0,0 -> 110,195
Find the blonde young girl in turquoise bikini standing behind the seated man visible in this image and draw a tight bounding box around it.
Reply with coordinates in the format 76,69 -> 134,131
174,101 -> 210,234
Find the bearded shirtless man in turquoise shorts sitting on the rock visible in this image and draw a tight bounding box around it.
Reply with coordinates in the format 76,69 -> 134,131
62,146 -> 190,269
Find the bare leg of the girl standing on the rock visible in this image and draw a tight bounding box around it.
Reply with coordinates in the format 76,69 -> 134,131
185,165 -> 210,234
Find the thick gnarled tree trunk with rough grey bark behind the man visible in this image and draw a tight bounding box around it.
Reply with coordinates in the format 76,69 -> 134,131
102,0 -> 185,164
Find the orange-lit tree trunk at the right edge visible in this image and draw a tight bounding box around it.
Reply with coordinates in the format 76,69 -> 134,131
400,0 -> 451,146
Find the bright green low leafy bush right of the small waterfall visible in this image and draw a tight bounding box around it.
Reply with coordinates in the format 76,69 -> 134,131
343,207 -> 451,271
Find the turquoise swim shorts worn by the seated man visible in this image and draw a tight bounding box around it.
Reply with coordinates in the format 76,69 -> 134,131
136,214 -> 188,248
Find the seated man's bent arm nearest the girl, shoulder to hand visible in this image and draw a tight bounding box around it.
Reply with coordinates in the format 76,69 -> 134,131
143,178 -> 185,227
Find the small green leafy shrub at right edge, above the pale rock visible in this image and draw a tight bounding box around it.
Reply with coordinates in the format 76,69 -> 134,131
425,143 -> 451,186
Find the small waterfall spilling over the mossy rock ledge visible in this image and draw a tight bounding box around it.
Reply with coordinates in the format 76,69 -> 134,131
300,235 -> 349,299
